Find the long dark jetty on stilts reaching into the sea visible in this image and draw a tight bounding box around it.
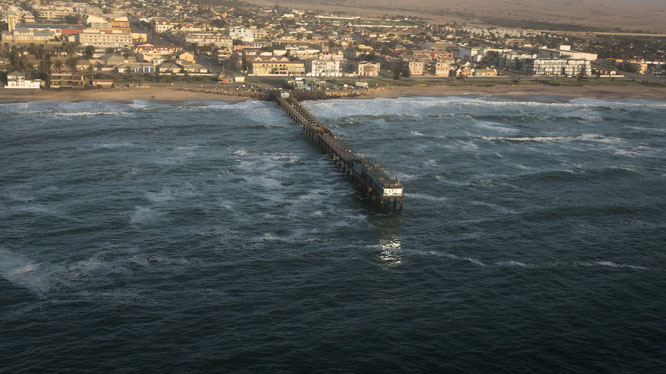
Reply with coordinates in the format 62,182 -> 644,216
274,92 -> 403,208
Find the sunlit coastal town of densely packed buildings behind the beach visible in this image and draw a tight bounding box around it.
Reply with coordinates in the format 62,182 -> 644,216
0,0 -> 666,96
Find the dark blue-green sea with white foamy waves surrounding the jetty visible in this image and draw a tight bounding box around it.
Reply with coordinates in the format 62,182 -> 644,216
0,97 -> 666,373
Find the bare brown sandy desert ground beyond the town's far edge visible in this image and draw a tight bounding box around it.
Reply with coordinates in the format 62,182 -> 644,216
249,0 -> 666,33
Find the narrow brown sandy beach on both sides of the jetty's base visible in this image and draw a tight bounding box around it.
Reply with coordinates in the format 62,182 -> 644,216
0,85 -> 666,104
